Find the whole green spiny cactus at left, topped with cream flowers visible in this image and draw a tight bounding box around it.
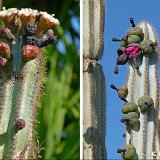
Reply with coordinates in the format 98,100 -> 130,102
0,8 -> 59,159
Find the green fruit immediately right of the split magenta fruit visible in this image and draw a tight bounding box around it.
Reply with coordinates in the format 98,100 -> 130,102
140,40 -> 155,55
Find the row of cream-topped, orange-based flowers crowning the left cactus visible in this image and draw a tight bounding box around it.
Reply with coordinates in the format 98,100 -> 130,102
0,8 -> 60,36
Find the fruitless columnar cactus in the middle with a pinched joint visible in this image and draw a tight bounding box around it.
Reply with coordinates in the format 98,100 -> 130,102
82,0 -> 106,159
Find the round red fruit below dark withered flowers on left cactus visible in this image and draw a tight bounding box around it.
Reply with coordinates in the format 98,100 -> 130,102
22,45 -> 40,61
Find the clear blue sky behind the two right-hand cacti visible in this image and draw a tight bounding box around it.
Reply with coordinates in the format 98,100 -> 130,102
100,0 -> 160,159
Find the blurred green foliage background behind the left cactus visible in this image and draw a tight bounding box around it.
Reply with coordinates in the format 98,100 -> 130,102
3,0 -> 80,159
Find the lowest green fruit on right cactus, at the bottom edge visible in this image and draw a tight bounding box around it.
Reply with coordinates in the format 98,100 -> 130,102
121,144 -> 136,160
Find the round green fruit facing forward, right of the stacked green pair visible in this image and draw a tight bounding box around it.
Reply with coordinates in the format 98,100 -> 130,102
138,96 -> 154,113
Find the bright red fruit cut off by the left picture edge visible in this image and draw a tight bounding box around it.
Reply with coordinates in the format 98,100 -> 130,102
0,42 -> 11,59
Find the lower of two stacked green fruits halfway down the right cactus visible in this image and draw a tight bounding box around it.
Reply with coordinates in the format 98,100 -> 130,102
121,112 -> 139,128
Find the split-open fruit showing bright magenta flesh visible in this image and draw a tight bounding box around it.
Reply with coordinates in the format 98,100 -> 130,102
125,45 -> 141,57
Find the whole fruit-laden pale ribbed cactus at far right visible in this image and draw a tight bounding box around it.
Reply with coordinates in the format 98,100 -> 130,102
111,18 -> 160,160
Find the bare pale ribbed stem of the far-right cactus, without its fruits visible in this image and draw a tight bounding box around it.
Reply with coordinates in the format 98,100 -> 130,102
126,21 -> 160,159
